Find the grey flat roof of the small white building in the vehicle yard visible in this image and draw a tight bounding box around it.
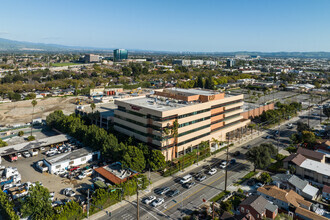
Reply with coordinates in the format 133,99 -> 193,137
44,147 -> 93,164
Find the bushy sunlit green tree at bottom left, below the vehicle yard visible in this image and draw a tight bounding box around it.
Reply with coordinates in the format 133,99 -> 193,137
21,183 -> 54,220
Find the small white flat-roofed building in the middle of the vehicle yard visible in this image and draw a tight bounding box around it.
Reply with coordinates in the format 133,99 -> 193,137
44,148 -> 101,174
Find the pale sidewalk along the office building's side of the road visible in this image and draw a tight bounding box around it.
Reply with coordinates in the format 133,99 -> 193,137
86,131 -> 266,219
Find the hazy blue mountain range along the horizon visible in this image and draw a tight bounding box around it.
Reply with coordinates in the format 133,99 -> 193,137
0,38 -> 330,59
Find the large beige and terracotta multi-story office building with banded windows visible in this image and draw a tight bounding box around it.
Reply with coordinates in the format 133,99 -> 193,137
114,88 -> 250,160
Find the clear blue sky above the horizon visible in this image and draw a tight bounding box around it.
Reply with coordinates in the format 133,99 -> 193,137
0,0 -> 330,52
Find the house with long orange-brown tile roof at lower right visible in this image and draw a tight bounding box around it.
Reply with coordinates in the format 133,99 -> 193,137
258,185 -> 312,210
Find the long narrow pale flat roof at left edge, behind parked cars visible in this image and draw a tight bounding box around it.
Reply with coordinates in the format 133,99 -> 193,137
0,134 -> 71,156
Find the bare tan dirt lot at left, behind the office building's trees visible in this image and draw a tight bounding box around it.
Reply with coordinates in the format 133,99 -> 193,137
0,97 -> 76,126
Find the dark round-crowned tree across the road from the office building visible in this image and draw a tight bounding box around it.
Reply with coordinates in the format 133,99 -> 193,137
246,144 -> 277,171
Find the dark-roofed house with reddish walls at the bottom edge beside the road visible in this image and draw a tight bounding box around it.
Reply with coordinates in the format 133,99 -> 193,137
239,195 -> 278,220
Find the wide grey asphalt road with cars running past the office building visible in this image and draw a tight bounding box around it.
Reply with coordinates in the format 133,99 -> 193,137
95,105 -> 328,220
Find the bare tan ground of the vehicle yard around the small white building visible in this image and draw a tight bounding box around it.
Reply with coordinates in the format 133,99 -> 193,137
1,147 -> 96,200
